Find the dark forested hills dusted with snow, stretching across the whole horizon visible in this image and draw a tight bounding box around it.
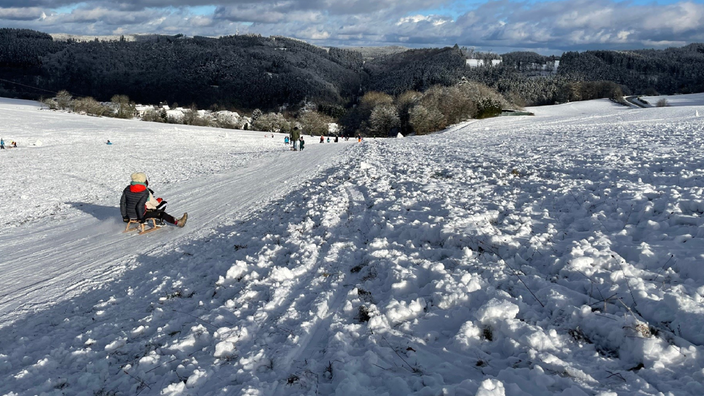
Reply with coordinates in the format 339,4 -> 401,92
0,29 -> 704,110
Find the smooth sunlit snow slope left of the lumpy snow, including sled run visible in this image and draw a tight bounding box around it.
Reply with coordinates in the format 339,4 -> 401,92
0,102 -> 350,328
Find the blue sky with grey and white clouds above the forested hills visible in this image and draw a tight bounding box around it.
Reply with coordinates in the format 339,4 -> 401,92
0,0 -> 704,55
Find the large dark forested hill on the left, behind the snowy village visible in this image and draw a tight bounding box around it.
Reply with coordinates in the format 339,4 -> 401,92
0,29 -> 363,109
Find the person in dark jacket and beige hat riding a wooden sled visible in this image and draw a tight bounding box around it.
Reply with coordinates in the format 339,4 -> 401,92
120,172 -> 188,227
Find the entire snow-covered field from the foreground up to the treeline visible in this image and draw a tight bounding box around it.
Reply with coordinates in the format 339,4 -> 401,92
0,94 -> 704,396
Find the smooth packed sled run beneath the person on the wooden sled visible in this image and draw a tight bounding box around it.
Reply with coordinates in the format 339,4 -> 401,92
0,145 -> 349,326
